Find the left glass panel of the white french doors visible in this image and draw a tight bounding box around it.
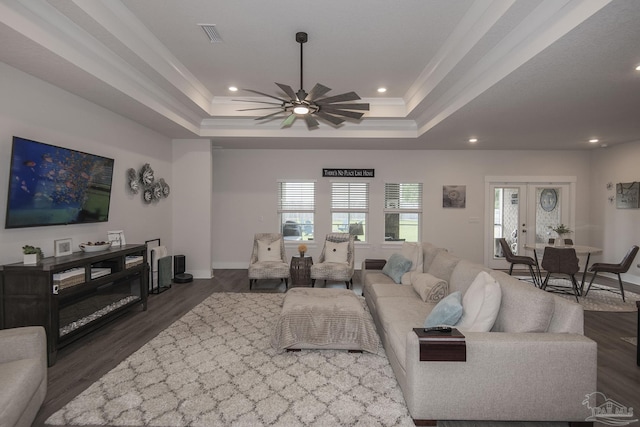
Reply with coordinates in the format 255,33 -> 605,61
493,187 -> 520,259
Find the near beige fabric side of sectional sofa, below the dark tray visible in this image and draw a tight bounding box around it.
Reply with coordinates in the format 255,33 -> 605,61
405,331 -> 597,421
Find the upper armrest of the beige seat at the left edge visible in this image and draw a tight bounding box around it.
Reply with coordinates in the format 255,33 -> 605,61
0,326 -> 47,366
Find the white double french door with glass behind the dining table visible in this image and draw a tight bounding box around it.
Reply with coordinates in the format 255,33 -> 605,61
485,177 -> 575,269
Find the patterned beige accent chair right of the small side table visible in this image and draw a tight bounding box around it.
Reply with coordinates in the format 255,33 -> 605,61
311,233 -> 355,289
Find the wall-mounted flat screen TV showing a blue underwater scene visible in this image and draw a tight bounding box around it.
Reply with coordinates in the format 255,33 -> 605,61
5,136 -> 113,228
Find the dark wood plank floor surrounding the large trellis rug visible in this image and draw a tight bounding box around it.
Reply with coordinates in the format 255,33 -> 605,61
33,270 -> 640,426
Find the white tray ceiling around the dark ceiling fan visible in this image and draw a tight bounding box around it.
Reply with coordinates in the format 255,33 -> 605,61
0,0 -> 640,149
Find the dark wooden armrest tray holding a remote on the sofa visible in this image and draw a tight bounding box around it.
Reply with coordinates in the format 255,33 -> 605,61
413,328 -> 467,362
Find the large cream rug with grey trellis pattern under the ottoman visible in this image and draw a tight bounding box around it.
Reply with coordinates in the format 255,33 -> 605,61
46,293 -> 413,427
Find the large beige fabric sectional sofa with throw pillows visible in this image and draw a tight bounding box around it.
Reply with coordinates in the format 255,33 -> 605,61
362,243 -> 597,425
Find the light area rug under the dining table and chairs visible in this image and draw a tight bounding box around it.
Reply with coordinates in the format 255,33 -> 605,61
518,276 -> 640,312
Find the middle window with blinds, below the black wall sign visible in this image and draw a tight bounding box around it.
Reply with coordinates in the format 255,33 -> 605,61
331,182 -> 369,241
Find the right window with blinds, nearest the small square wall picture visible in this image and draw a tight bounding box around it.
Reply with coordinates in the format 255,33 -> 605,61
384,183 -> 422,242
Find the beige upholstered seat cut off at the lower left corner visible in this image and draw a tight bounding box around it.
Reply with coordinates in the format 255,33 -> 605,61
0,326 -> 47,427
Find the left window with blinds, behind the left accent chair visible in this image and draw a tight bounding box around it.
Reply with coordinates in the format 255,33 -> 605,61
278,181 -> 316,240
